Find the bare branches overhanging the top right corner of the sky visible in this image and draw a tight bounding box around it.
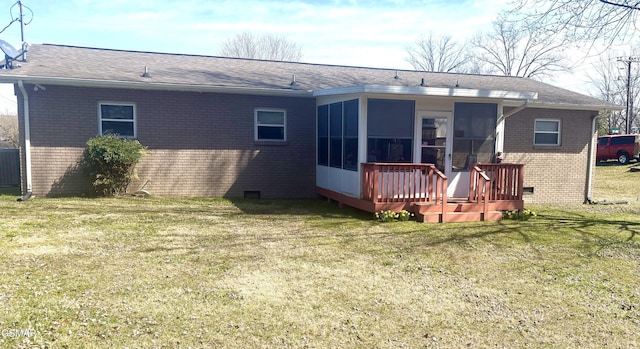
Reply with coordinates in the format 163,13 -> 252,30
509,0 -> 640,45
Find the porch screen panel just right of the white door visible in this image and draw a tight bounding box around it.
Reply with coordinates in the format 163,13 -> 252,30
452,103 -> 498,171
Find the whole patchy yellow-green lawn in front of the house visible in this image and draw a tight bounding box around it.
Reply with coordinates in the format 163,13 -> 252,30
0,165 -> 640,348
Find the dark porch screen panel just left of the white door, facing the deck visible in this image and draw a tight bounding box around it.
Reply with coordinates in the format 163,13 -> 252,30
367,99 -> 416,162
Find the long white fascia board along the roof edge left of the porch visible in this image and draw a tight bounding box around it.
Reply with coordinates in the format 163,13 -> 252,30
0,75 -> 313,97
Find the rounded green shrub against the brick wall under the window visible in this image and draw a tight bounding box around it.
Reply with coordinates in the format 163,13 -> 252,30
82,135 -> 146,196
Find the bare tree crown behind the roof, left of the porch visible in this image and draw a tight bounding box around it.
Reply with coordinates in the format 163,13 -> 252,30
220,32 -> 302,62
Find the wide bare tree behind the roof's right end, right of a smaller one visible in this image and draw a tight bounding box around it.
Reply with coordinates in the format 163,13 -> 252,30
472,16 -> 570,78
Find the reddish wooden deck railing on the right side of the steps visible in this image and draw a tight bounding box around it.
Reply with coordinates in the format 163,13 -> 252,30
469,164 -> 524,202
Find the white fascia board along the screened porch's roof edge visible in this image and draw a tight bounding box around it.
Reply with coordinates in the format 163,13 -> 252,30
313,85 -> 538,100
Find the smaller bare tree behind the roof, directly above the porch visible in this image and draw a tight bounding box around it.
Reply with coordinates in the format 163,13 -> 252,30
407,32 -> 471,73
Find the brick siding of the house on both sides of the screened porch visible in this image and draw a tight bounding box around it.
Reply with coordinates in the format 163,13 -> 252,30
18,85 -> 594,203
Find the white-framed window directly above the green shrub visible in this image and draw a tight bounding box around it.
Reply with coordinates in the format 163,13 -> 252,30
98,102 -> 137,138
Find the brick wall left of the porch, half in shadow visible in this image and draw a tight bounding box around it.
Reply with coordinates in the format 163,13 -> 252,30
20,85 -> 315,197
